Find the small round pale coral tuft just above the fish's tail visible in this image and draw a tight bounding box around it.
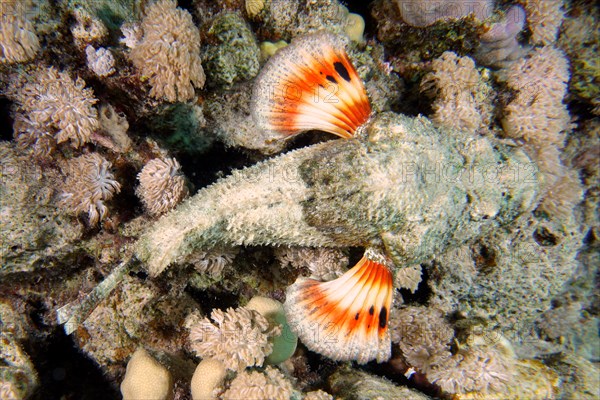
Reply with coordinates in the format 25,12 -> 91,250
136,158 -> 188,215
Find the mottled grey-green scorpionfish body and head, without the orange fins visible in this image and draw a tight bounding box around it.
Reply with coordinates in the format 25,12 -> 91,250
137,113 -> 537,275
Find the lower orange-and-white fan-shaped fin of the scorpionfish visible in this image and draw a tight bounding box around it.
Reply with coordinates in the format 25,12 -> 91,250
284,250 -> 394,364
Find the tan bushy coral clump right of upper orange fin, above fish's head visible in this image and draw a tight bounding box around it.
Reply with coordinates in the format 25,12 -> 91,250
421,52 -> 493,131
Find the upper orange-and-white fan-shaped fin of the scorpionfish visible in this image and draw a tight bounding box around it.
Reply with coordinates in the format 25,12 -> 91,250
251,32 -> 371,138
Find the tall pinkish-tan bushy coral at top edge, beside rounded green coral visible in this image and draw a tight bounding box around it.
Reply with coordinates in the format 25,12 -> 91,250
130,0 -> 205,102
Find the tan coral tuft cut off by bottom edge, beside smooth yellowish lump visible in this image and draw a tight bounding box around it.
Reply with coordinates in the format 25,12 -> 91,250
222,367 -> 293,400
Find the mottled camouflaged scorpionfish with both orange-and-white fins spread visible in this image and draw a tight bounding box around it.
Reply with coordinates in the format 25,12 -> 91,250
137,33 -> 538,363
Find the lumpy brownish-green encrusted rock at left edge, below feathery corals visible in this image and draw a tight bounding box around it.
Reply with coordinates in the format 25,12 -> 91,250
0,142 -> 83,276
